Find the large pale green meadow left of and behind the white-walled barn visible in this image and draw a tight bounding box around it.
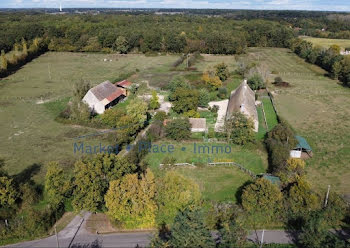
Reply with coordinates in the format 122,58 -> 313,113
0,52 -> 235,182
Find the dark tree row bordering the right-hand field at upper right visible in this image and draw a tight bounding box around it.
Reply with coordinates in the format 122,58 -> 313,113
291,39 -> 350,86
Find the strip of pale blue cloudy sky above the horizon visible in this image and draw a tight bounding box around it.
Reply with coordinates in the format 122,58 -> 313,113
0,0 -> 350,11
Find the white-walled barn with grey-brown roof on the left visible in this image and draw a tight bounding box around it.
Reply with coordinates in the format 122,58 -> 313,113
83,81 -> 126,114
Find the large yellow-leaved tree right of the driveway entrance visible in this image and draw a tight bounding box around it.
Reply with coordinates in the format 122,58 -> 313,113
105,169 -> 157,228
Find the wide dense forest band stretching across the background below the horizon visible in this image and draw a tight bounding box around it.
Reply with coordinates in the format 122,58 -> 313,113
0,14 -> 294,54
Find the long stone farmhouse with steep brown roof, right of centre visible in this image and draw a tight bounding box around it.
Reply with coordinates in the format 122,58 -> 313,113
226,80 -> 259,132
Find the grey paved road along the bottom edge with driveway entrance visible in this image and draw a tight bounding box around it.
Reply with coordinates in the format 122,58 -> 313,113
6,213 -> 298,248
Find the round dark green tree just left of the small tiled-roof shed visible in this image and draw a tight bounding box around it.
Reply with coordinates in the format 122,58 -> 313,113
165,118 -> 191,140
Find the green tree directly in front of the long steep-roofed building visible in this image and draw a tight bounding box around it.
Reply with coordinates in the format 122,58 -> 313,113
225,112 -> 255,145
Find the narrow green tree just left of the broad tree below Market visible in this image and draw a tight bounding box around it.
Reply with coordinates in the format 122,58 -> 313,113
45,162 -> 70,207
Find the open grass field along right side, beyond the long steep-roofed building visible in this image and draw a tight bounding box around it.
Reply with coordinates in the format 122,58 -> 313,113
241,48 -> 350,194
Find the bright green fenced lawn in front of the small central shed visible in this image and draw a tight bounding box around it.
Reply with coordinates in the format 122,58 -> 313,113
145,142 -> 267,201
